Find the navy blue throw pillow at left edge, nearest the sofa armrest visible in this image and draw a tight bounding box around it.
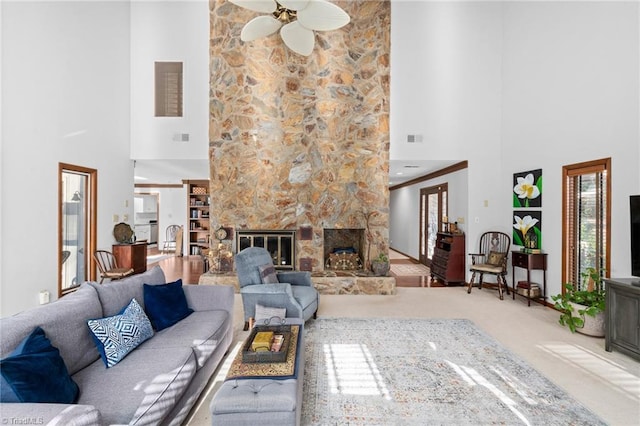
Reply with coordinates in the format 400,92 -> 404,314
0,327 -> 80,404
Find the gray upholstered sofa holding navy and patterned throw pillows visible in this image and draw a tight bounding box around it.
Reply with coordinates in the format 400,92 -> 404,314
0,266 -> 234,425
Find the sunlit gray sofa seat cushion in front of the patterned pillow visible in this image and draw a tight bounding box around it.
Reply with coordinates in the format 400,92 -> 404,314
73,346 -> 196,425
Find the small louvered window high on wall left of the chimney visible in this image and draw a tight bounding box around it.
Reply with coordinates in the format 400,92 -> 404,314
155,62 -> 182,117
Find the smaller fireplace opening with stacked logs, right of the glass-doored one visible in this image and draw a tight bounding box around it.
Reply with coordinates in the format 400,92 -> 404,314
324,228 -> 365,271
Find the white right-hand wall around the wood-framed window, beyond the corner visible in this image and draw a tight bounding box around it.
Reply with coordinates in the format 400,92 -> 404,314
502,2 -> 640,294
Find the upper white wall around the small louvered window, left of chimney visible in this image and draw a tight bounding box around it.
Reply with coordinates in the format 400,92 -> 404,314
131,0 -> 209,160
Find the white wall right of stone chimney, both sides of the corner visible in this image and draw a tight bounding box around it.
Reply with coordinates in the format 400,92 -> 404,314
391,1 -> 640,295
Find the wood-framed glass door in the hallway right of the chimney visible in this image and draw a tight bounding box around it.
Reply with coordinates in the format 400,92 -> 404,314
418,183 -> 448,267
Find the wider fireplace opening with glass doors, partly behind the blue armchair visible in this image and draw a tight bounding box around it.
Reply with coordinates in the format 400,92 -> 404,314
236,229 -> 296,270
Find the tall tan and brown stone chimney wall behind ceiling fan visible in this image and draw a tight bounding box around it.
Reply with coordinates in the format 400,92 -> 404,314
209,0 -> 390,271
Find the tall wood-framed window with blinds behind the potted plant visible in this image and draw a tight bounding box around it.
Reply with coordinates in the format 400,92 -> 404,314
562,158 -> 611,291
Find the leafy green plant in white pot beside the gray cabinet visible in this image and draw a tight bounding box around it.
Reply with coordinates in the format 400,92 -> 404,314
551,268 -> 606,337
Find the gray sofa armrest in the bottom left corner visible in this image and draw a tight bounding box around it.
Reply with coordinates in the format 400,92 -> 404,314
0,402 -> 102,426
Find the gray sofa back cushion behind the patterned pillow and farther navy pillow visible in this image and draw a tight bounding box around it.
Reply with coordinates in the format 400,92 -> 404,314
91,265 -> 167,318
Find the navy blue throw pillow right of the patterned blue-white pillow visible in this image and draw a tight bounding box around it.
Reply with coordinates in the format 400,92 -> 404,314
143,279 -> 193,331
